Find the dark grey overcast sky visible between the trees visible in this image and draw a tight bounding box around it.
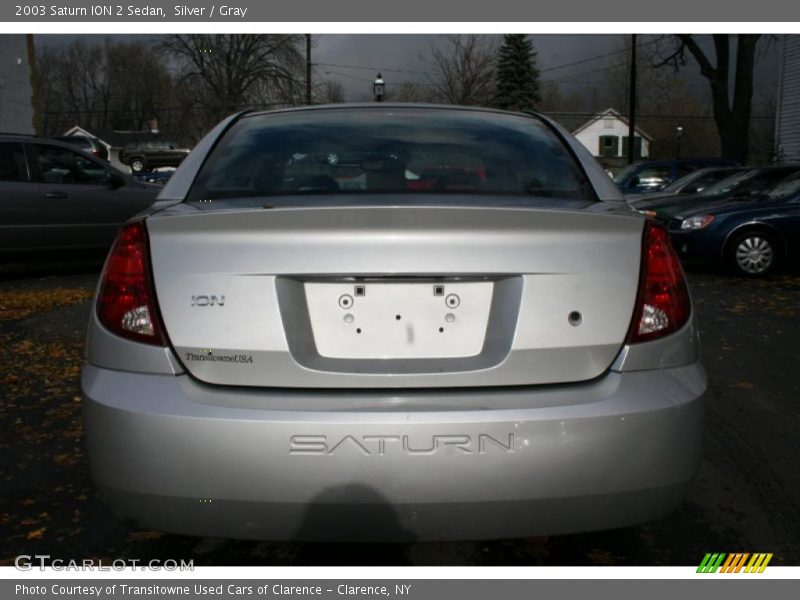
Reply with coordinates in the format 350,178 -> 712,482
36,34 -> 778,110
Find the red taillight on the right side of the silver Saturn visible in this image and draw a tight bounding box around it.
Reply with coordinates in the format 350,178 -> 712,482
628,221 -> 691,344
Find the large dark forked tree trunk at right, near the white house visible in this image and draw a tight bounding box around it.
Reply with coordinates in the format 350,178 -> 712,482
660,34 -> 761,162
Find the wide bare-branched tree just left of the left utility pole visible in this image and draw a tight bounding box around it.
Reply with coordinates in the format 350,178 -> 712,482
163,34 -> 305,119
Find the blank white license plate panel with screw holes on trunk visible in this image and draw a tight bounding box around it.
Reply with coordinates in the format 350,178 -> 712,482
305,281 -> 494,359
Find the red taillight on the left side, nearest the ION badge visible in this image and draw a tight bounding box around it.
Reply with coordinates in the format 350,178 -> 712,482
97,221 -> 166,346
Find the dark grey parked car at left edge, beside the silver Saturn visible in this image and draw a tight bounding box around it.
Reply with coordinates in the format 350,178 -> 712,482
0,135 -> 160,255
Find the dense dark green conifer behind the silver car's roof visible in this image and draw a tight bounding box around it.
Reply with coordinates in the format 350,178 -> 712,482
494,33 -> 542,111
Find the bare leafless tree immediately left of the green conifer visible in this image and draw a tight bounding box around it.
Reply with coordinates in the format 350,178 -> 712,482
429,35 -> 496,106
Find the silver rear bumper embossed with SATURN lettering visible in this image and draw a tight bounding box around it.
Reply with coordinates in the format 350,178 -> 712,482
82,364 -> 706,541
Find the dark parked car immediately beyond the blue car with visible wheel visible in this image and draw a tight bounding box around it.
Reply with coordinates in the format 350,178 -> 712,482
630,165 -> 800,224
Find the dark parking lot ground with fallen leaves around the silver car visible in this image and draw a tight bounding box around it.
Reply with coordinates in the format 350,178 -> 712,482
0,258 -> 800,565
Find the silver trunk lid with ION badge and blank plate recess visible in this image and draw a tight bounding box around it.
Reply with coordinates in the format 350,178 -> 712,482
148,205 -> 642,388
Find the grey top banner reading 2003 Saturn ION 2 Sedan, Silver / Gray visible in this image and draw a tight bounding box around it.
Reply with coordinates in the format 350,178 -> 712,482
0,0 -> 800,23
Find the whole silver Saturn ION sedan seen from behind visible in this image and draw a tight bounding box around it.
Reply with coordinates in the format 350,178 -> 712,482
82,104 -> 706,541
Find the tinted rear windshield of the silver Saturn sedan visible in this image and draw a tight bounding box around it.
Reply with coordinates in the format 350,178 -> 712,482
188,108 -> 596,203
